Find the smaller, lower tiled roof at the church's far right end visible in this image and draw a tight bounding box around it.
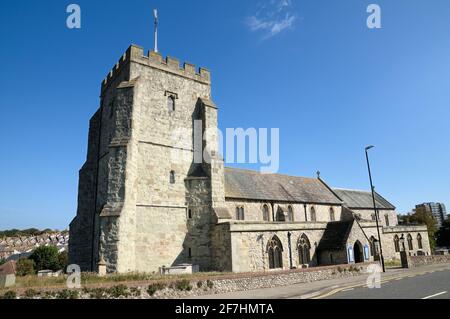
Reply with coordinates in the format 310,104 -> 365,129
333,188 -> 395,209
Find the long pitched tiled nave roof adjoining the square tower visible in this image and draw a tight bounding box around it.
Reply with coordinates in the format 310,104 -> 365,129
225,168 -> 342,204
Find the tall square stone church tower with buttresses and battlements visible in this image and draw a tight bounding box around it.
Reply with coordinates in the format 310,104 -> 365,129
69,45 -> 225,273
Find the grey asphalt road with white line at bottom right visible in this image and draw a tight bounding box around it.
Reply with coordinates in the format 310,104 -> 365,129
323,269 -> 450,299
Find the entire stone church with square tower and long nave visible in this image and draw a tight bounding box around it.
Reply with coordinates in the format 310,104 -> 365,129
69,45 -> 431,273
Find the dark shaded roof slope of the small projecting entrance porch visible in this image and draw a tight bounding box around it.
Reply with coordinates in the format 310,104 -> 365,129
317,220 -> 354,250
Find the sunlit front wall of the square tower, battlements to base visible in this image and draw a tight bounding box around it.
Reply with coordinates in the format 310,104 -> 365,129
124,47 -> 213,272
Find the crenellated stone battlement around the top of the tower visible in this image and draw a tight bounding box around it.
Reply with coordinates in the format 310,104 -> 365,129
102,44 -> 211,92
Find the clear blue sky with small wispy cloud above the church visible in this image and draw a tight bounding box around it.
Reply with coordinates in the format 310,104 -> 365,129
0,0 -> 450,229
